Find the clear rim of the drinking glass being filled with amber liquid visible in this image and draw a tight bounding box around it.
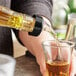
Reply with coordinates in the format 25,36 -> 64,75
42,40 -> 75,48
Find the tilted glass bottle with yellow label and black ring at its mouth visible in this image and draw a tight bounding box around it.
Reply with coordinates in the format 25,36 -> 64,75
0,6 -> 43,36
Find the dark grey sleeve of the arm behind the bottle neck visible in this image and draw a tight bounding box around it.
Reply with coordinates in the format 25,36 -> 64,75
11,0 -> 53,44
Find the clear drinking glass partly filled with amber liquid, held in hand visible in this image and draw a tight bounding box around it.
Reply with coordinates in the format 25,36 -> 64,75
42,40 -> 74,76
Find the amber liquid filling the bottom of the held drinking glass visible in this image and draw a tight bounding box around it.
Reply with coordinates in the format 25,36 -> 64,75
46,61 -> 69,76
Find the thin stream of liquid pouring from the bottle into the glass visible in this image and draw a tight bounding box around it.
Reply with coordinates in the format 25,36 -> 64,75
43,21 -> 62,61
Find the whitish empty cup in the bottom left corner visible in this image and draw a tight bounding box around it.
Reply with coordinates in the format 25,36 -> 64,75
0,54 -> 16,76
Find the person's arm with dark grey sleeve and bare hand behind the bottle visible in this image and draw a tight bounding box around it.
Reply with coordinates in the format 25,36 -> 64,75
12,0 -> 52,74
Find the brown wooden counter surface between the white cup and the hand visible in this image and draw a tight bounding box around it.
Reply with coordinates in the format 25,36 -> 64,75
15,56 -> 42,76
